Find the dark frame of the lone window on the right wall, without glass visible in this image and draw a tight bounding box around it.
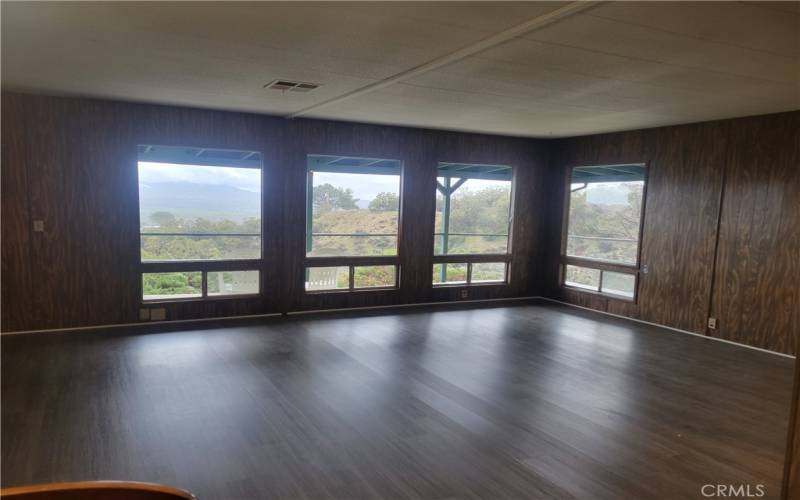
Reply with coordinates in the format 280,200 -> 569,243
558,160 -> 650,304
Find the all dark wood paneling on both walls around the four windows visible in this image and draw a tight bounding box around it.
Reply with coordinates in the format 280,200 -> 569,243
2,93 -> 800,354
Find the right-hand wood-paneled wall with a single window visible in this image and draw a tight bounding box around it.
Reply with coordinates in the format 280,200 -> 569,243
539,112 -> 800,354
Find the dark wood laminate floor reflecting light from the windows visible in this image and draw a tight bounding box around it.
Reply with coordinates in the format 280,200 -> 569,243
2,303 -> 793,499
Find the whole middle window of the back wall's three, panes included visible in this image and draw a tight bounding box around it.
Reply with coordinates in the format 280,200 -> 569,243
305,155 -> 402,292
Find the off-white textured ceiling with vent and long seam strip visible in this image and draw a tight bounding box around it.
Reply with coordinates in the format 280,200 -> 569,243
2,2 -> 800,137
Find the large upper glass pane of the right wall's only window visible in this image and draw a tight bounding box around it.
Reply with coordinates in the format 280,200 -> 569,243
567,165 -> 645,265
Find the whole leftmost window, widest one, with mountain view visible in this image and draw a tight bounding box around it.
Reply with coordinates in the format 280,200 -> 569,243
138,145 -> 262,300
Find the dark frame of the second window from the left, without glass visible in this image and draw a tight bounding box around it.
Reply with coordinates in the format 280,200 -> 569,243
301,153 -> 405,295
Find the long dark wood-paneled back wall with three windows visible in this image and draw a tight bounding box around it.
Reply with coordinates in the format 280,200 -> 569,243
2,93 -> 546,331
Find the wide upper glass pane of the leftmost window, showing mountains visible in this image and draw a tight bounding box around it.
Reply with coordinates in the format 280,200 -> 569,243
138,146 -> 261,262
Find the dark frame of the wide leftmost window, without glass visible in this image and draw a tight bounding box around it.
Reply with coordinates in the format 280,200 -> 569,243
134,141 -> 266,305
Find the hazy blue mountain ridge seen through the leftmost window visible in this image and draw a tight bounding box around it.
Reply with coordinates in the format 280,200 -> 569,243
139,182 -> 261,224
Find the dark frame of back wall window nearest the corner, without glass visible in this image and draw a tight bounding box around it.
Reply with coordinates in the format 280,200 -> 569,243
430,161 -> 517,288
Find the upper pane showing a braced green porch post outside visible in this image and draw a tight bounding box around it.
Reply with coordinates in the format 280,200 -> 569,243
433,163 -> 512,255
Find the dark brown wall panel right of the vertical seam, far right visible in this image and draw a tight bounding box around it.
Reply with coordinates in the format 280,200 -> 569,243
710,113 -> 800,354
